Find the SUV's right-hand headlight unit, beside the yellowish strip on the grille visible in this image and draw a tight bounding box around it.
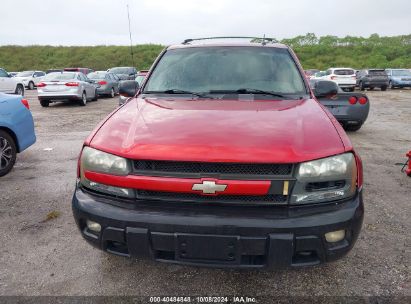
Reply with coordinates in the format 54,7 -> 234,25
291,153 -> 357,204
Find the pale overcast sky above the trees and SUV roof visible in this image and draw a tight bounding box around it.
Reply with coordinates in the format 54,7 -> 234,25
0,0 -> 411,45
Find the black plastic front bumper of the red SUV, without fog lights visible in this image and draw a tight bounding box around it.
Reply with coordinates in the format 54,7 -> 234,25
72,188 -> 364,268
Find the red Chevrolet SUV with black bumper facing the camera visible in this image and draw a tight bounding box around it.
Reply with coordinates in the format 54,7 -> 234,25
72,39 -> 364,268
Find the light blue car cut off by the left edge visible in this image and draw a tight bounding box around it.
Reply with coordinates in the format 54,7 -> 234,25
0,93 -> 36,176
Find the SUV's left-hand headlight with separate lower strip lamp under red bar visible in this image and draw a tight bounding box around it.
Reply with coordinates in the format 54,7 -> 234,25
80,147 -> 134,197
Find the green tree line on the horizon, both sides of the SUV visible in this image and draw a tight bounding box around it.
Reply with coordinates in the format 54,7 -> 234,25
0,33 -> 411,71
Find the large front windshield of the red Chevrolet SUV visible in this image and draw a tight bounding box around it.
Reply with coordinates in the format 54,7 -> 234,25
144,47 -> 307,95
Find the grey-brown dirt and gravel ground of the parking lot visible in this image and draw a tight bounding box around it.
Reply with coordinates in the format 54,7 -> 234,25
0,90 -> 411,297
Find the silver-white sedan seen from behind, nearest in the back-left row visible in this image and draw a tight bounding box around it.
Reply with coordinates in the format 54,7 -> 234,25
37,72 -> 99,107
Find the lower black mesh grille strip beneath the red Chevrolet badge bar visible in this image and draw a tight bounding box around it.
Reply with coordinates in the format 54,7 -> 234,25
136,190 -> 287,205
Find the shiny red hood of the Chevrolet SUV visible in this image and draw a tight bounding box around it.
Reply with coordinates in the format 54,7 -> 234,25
89,99 -> 345,163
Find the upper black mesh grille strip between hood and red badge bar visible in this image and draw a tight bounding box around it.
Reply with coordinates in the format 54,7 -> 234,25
134,160 -> 293,179
